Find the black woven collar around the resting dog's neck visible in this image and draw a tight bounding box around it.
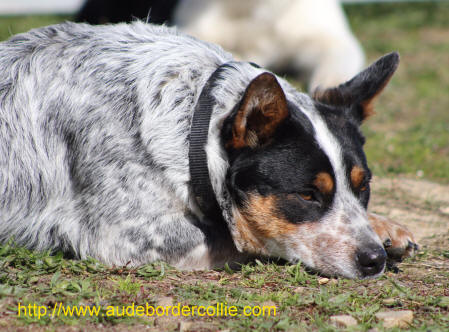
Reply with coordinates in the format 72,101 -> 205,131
189,63 -> 230,223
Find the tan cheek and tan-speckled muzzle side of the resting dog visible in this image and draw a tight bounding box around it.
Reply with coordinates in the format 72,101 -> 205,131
233,193 -> 368,277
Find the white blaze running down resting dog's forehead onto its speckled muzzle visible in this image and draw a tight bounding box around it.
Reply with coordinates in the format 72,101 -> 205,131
280,99 -> 381,278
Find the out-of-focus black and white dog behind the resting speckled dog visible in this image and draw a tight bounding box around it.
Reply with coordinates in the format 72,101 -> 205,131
76,0 -> 365,92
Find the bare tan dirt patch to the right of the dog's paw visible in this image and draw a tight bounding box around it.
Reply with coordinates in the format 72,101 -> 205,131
369,177 -> 449,242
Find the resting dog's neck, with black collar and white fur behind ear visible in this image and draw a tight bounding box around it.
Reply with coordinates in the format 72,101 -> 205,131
189,61 -> 268,252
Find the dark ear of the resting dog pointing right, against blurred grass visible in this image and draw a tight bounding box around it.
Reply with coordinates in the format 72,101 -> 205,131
313,52 -> 399,123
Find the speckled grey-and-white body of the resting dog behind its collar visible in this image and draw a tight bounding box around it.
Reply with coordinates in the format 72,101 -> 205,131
0,22 -> 231,263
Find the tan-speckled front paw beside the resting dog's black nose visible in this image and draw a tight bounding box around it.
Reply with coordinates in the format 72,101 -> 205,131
368,213 -> 418,263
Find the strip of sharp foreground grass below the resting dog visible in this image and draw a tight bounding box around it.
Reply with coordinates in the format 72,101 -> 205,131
0,237 -> 449,331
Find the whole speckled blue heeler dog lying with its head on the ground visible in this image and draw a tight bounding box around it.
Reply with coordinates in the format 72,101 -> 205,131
0,22 -> 416,278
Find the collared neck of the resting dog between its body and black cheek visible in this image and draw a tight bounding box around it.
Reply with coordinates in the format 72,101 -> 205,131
189,61 -> 260,225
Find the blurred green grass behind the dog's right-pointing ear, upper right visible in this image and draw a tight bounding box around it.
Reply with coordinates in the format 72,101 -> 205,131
346,3 -> 449,183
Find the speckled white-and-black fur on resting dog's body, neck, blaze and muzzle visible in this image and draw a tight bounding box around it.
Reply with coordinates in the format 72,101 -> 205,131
0,22 -> 412,277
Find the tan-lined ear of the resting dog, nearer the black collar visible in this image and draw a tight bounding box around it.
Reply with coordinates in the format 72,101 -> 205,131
225,73 -> 288,149
